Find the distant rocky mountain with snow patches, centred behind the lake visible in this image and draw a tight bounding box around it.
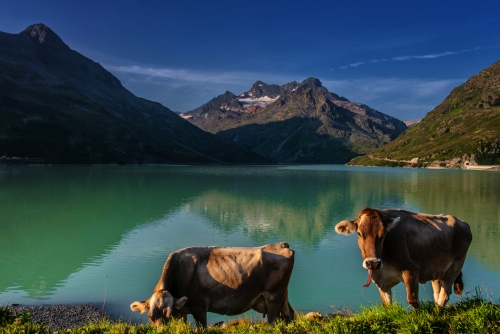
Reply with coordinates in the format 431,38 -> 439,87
182,78 -> 407,163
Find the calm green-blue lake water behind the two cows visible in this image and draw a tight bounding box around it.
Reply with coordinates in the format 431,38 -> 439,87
0,165 -> 500,323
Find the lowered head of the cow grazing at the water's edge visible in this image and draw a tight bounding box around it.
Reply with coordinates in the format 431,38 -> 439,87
130,290 -> 187,326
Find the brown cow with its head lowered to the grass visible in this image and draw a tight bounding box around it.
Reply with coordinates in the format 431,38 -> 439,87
130,242 -> 294,327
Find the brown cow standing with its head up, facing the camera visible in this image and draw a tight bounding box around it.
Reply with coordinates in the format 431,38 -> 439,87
335,208 -> 472,309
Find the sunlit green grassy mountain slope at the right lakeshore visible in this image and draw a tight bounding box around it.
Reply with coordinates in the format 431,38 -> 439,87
349,61 -> 500,167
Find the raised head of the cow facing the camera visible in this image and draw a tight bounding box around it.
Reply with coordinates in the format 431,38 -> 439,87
335,208 -> 400,270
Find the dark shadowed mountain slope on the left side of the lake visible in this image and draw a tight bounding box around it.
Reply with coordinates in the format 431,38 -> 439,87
0,24 -> 265,164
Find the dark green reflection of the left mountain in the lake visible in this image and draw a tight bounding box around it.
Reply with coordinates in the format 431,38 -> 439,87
0,167 -> 203,298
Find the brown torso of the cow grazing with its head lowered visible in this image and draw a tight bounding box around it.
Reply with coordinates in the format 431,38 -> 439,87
167,243 -> 294,299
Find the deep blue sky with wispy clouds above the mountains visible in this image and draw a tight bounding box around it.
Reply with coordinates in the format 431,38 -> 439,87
0,0 -> 500,120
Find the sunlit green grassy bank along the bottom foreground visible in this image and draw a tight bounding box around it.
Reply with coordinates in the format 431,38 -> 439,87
0,297 -> 500,334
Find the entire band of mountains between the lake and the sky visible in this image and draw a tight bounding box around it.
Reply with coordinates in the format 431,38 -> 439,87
4,24 -> 500,168
